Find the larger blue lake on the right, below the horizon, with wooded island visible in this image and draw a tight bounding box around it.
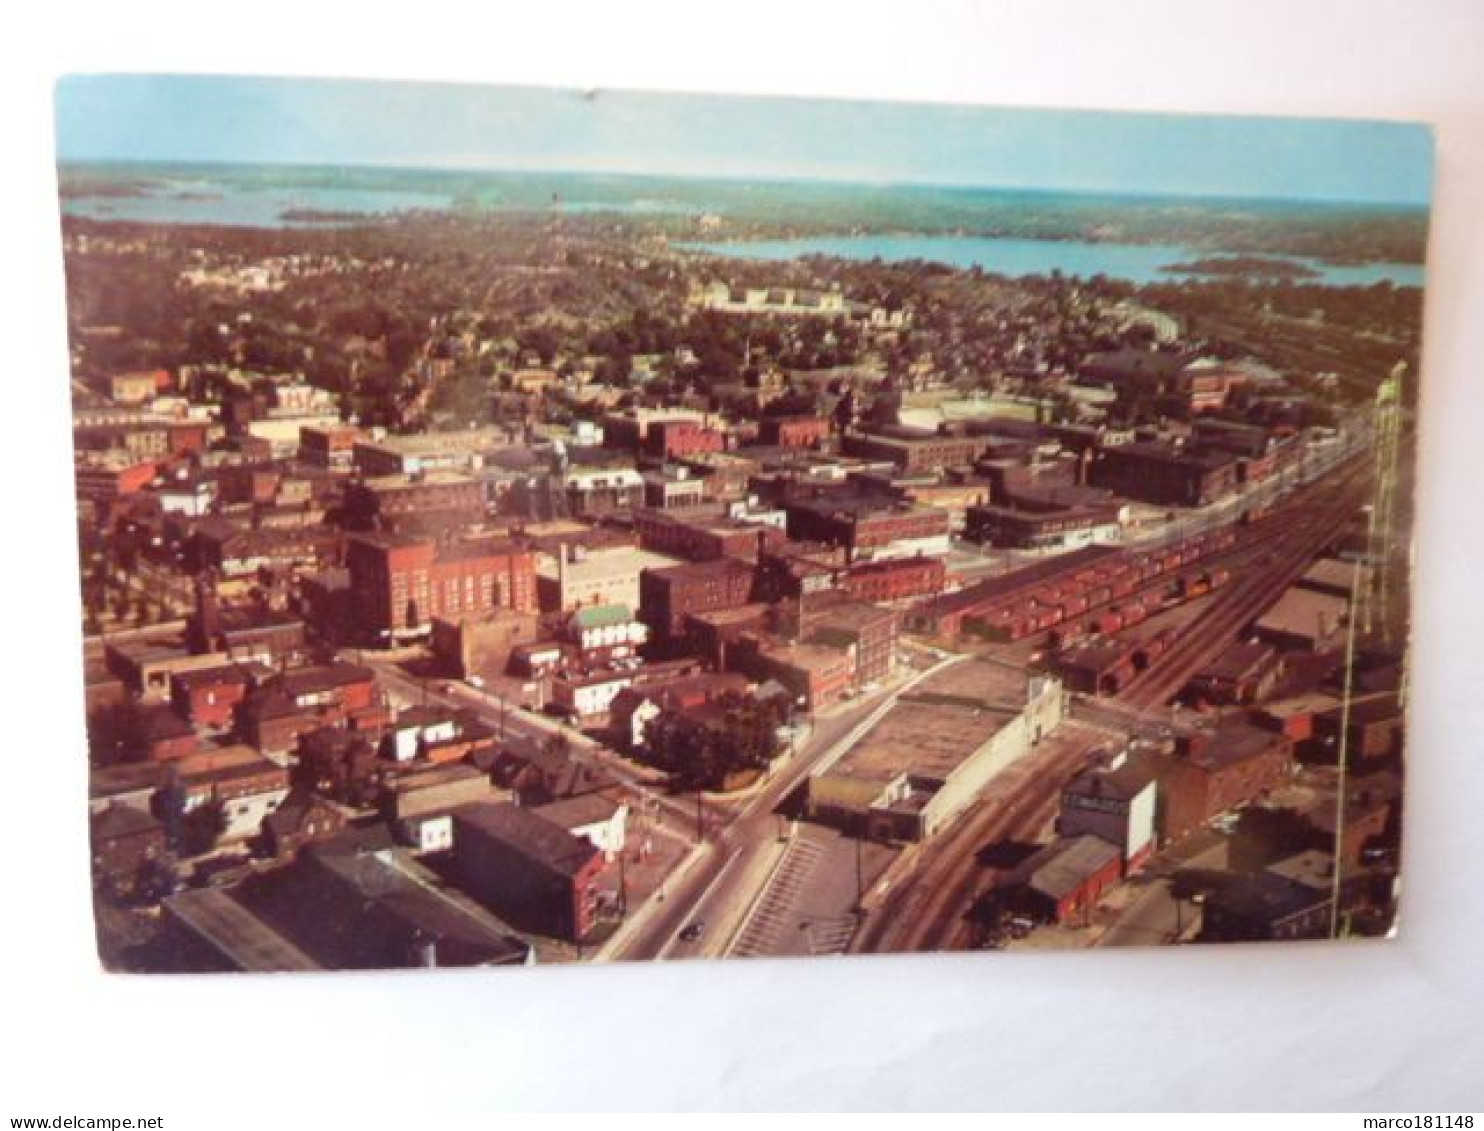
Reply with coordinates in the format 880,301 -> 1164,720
684,236 -> 1422,286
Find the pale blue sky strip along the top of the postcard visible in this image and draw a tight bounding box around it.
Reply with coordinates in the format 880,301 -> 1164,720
56,76 -> 1432,203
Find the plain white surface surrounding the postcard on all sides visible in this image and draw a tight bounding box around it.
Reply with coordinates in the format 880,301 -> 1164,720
0,0 -> 1484,1110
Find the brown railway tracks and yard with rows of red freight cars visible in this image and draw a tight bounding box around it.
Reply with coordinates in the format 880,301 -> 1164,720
850,448 -> 1394,951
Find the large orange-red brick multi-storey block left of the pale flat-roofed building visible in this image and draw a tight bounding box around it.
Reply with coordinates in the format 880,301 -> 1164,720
346,534 -> 537,641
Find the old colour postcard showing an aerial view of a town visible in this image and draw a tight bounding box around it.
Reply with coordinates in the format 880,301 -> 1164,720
55,76 -> 1434,977
